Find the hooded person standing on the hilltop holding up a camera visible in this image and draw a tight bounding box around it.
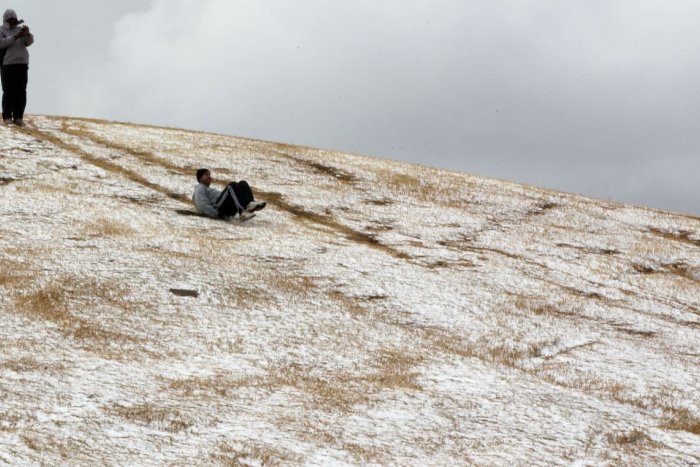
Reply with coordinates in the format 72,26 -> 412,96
0,9 -> 34,126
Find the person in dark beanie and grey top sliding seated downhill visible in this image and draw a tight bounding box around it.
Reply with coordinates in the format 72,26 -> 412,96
192,169 -> 267,222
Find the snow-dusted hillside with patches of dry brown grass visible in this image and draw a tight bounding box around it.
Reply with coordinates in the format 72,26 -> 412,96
0,116 -> 700,465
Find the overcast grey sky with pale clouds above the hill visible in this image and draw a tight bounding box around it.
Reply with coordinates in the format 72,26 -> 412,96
7,0 -> 700,215
